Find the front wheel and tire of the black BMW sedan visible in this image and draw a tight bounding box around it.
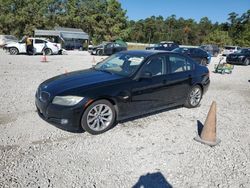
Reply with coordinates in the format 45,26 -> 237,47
81,100 -> 116,135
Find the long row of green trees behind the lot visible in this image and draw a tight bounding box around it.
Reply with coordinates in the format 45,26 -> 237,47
0,0 -> 250,46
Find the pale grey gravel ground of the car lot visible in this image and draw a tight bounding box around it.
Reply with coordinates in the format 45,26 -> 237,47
0,50 -> 250,188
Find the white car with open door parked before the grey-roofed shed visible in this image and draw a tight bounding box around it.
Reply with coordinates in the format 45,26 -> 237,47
5,38 -> 62,55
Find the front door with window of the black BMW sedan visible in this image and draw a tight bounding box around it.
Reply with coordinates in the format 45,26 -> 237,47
130,56 -> 167,115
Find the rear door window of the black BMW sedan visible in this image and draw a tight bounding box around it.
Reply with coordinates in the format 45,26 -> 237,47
168,55 -> 193,73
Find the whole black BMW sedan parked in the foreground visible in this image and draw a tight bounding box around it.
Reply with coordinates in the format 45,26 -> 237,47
35,50 -> 210,134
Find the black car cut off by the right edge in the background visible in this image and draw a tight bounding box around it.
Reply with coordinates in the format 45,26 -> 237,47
226,48 -> 250,66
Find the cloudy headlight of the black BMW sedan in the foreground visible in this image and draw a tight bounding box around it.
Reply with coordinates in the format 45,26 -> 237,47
52,96 -> 84,106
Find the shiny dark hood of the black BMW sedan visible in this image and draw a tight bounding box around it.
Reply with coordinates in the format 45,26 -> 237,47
40,69 -> 124,95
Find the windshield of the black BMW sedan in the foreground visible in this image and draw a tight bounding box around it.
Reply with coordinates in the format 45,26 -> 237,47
94,53 -> 145,76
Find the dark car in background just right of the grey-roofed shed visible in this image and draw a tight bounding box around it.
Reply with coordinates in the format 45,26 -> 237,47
89,42 -> 127,55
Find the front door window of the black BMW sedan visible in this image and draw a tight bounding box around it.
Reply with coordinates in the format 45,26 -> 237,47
142,57 -> 164,76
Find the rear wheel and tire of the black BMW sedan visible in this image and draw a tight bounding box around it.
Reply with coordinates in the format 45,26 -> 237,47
184,85 -> 202,108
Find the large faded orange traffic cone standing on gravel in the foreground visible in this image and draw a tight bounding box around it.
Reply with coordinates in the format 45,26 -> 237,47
194,101 -> 221,146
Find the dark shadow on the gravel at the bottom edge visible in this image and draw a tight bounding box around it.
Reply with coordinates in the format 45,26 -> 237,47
132,172 -> 172,188
